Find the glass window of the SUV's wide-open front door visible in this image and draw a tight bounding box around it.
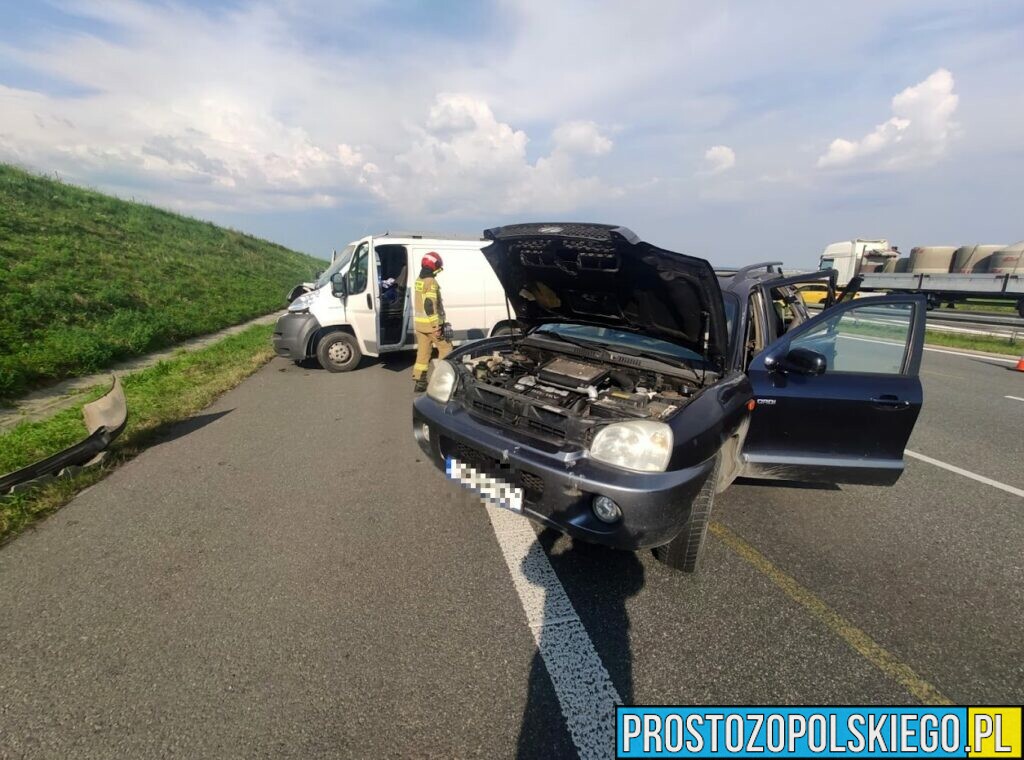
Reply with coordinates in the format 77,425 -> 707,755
790,303 -> 913,375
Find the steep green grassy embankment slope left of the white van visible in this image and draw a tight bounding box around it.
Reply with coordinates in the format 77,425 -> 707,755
0,164 -> 325,403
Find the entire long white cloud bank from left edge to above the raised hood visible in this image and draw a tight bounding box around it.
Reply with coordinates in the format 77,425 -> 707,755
0,0 -> 612,216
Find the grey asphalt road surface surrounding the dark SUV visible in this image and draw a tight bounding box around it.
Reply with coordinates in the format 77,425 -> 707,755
0,351 -> 1024,758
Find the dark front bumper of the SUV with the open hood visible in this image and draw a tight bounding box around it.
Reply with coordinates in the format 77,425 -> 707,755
413,396 -> 714,549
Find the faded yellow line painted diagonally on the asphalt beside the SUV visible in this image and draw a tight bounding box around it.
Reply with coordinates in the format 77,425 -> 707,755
710,522 -> 953,705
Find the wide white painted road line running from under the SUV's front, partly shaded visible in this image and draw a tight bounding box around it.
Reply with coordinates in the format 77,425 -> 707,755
487,506 -> 623,760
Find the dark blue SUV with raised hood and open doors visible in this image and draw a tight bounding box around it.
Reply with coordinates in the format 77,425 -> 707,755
413,223 -> 925,572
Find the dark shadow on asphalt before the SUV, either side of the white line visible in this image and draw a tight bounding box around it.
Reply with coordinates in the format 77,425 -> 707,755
516,529 -> 644,758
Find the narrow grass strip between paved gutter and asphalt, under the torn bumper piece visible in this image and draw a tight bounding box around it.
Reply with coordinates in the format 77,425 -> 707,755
0,325 -> 273,541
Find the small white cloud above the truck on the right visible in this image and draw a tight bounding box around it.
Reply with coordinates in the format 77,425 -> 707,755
817,69 -> 959,169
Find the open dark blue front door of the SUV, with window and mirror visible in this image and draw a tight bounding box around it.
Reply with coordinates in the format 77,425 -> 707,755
741,296 -> 926,485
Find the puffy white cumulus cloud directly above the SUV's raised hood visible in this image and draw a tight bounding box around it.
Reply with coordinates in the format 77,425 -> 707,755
372,93 -> 615,215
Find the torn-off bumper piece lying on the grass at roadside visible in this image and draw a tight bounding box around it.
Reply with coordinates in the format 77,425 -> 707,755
0,377 -> 128,496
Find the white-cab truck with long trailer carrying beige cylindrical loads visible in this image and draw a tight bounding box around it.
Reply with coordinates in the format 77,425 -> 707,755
818,239 -> 1024,318
